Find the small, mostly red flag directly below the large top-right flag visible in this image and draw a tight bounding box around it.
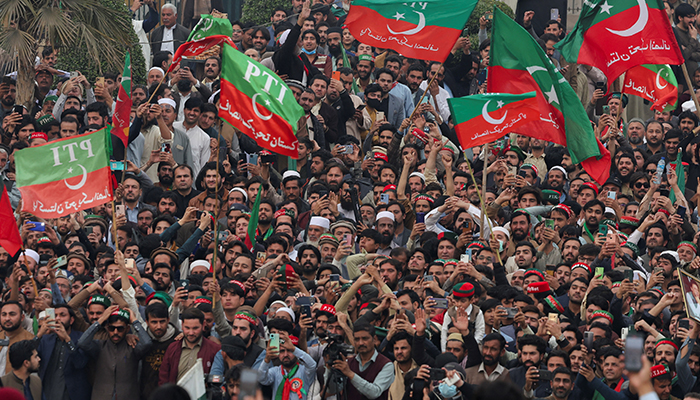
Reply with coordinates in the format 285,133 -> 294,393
622,64 -> 678,112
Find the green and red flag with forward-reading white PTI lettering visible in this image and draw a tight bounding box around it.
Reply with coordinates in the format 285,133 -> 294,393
219,42 -> 304,159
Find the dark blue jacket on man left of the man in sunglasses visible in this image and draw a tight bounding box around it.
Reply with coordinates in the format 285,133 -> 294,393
37,330 -> 92,400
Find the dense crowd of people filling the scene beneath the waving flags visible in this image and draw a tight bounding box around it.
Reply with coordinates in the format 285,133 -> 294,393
0,0 -> 700,400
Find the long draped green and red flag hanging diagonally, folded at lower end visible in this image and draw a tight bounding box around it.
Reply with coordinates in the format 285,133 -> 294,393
487,9 -> 610,185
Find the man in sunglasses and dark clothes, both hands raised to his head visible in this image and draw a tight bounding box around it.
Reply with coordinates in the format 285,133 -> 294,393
78,306 -> 151,400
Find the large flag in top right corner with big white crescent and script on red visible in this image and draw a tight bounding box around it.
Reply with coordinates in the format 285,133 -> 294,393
555,0 -> 683,85
